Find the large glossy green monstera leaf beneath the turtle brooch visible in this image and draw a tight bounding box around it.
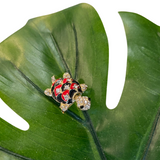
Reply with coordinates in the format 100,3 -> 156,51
0,4 -> 160,160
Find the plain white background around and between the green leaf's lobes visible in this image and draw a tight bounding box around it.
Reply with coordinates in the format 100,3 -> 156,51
0,0 -> 160,130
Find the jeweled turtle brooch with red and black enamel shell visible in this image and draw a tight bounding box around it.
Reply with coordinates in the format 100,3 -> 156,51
44,73 -> 91,113
